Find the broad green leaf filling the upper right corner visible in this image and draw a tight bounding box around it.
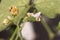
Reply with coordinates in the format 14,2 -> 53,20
35,0 -> 60,17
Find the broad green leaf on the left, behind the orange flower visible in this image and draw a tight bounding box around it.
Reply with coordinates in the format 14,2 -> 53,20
0,0 -> 28,31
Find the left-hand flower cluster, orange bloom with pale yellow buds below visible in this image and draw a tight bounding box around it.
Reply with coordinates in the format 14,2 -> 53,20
3,6 -> 18,25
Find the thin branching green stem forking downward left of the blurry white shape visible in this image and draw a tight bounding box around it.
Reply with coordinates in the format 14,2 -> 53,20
10,6 -> 30,40
